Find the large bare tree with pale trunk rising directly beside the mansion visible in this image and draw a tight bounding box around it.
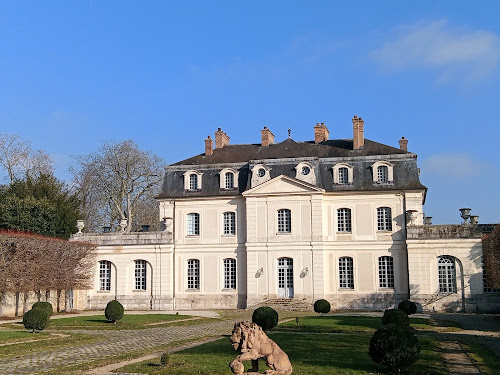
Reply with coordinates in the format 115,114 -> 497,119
71,140 -> 164,231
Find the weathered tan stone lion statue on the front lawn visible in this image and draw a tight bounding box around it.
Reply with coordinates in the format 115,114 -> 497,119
229,322 -> 293,375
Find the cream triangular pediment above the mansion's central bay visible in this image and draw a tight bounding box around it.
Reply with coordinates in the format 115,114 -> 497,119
243,175 -> 325,196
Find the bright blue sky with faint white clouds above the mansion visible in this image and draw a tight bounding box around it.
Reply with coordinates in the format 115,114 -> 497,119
0,0 -> 500,223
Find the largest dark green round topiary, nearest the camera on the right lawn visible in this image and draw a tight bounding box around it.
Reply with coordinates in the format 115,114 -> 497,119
368,324 -> 420,371
